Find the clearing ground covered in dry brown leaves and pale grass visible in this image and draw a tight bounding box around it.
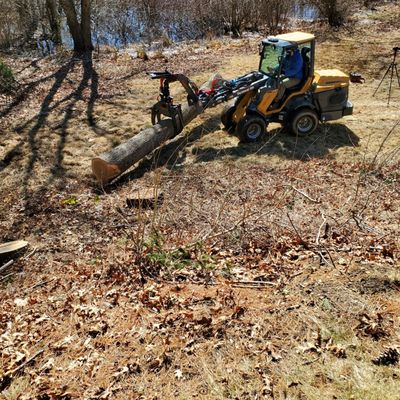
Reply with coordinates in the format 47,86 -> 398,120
0,4 -> 400,400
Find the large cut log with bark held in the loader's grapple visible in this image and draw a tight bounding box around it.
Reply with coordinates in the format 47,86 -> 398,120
92,103 -> 203,185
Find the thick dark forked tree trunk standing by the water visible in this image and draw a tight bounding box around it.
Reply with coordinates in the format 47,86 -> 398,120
60,0 -> 93,53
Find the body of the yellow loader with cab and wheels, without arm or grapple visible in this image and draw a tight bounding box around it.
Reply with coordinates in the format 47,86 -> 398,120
221,32 -> 353,142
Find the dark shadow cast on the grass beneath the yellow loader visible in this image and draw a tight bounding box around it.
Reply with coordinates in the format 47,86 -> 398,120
192,123 -> 359,162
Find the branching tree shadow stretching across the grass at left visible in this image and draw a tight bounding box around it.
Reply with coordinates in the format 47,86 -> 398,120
0,54 -> 99,212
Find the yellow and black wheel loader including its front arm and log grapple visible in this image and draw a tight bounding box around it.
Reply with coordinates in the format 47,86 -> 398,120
148,32 -> 353,142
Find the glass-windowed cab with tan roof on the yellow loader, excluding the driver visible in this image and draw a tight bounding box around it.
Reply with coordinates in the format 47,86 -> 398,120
259,32 -> 315,91
